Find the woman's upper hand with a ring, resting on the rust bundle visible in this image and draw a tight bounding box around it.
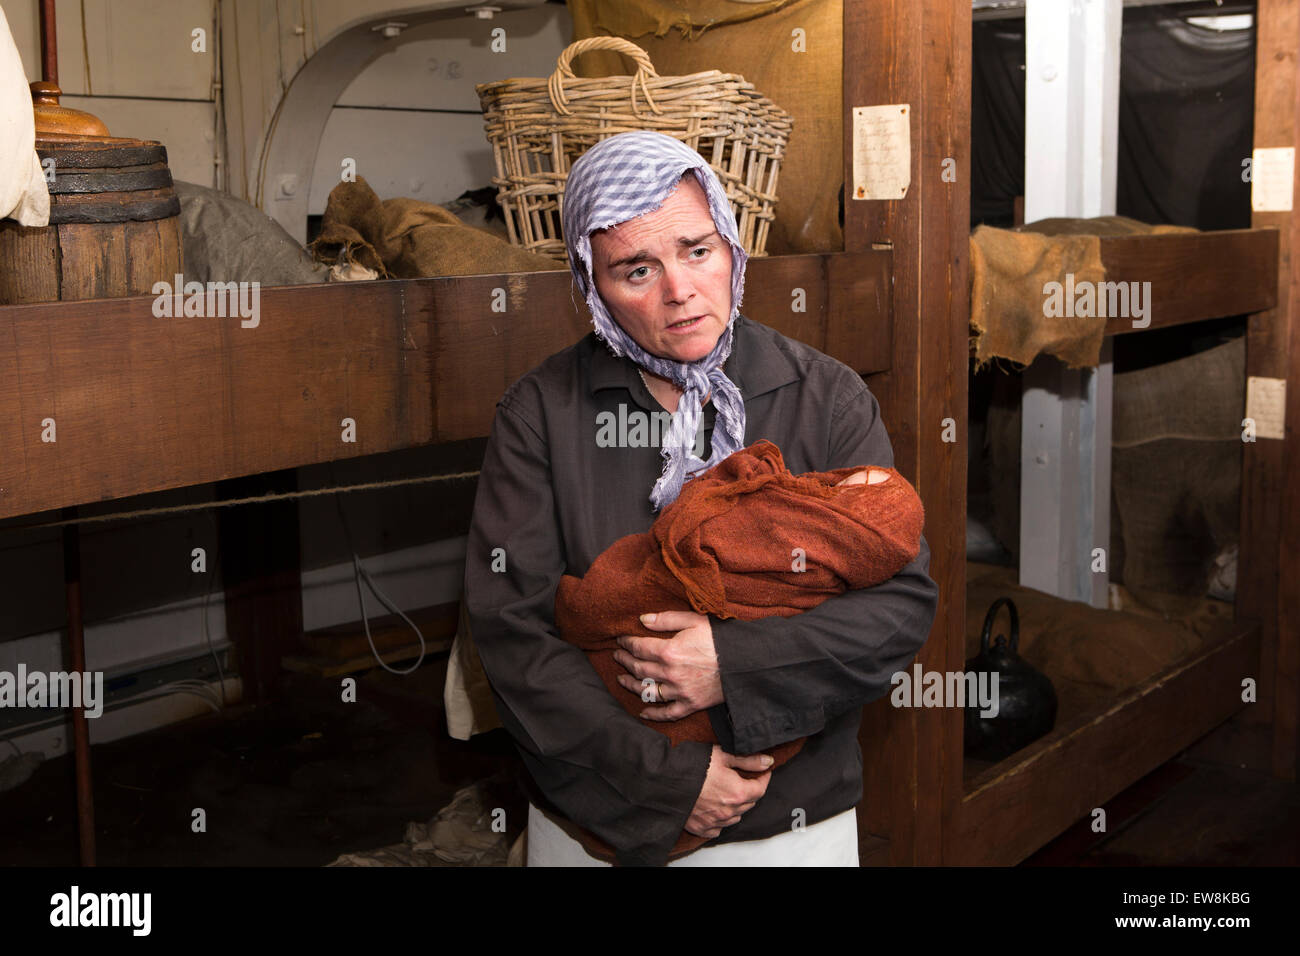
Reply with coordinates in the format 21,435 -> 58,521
614,611 -> 725,721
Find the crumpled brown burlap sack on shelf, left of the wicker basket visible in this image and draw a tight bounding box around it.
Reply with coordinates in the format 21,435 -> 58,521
311,177 -> 568,278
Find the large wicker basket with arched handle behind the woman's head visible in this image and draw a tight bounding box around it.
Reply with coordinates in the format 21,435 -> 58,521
475,36 -> 792,261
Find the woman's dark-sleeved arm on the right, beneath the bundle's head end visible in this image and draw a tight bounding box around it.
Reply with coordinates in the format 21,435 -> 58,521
709,385 -> 939,753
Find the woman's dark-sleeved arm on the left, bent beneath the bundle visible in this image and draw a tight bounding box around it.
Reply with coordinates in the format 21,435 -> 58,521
465,389 -> 712,865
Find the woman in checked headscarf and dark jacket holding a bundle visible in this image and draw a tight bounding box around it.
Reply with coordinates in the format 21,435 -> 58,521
465,133 -> 937,865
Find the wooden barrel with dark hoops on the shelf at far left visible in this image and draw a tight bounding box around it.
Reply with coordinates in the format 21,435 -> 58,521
0,137 -> 185,306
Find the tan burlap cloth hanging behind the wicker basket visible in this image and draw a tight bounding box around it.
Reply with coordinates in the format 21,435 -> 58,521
568,0 -> 844,255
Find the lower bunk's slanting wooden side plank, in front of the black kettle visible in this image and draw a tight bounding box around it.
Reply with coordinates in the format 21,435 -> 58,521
944,624 -> 1260,866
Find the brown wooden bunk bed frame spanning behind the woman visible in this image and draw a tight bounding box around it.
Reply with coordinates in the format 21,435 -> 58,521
0,0 -> 1300,865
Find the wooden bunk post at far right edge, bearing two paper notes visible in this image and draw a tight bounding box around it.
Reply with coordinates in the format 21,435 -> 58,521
1227,0 -> 1300,780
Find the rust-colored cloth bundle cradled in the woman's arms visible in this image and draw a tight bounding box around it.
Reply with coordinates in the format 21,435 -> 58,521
555,440 -> 926,860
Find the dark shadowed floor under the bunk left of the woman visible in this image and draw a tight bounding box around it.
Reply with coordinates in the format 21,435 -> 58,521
0,654 -> 527,866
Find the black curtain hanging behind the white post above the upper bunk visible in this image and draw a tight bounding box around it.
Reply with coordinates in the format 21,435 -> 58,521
971,5 -> 1255,229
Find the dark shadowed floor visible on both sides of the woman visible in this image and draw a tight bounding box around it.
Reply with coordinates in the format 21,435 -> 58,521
0,657 -> 1300,866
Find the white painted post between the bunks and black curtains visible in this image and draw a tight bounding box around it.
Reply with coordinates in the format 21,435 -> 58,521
1021,0 -> 1123,607
